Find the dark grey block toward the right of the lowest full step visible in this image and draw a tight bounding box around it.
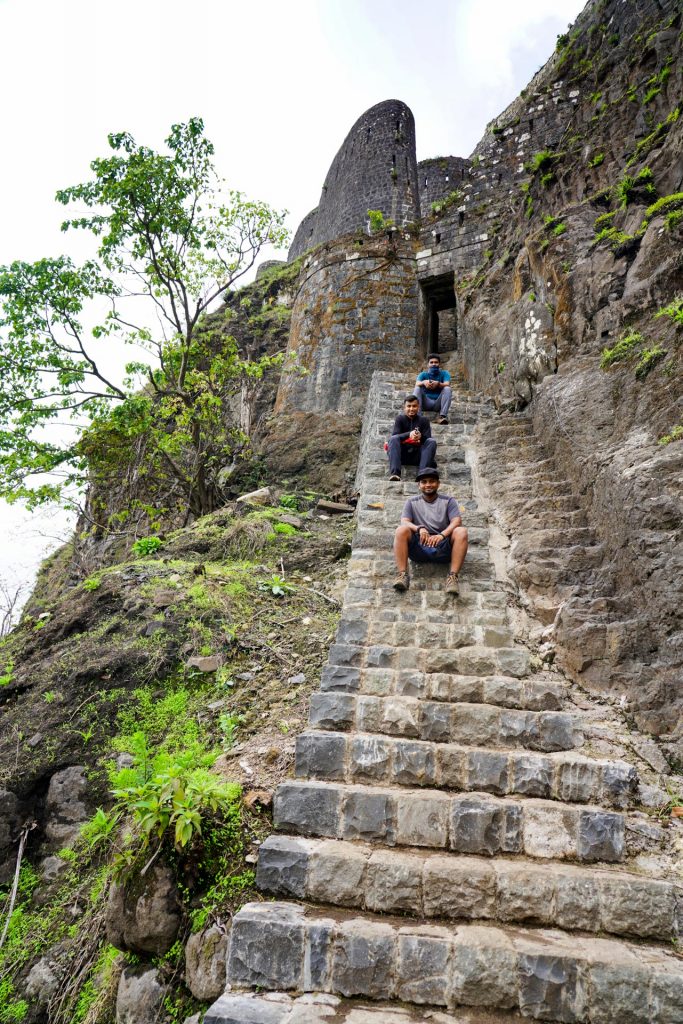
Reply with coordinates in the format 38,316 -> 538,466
519,953 -> 588,1024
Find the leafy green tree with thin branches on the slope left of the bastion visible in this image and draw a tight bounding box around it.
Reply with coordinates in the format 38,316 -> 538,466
0,118 -> 288,515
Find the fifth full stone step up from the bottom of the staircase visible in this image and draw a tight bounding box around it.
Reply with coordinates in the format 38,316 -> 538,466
310,692 -> 584,754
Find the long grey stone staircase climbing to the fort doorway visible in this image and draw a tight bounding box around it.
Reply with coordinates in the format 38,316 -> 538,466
205,373 -> 683,1024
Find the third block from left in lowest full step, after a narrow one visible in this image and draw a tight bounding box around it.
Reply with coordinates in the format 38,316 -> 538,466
332,919 -> 396,998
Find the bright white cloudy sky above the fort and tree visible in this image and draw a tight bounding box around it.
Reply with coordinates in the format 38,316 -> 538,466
0,0 -> 584,598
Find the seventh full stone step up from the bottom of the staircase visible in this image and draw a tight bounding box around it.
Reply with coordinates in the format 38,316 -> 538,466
329,638 -> 529,679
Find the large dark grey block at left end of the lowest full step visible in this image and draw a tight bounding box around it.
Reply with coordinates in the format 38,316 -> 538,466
227,903 -> 305,990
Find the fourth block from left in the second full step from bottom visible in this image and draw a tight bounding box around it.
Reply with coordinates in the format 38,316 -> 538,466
423,856 -> 496,920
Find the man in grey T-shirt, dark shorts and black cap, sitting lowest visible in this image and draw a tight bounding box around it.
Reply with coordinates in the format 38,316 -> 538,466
393,469 -> 467,594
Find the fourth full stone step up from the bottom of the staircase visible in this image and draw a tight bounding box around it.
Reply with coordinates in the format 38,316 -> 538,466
295,729 -> 638,809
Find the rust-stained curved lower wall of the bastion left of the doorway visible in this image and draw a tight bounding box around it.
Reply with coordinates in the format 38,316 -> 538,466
275,232 -> 419,415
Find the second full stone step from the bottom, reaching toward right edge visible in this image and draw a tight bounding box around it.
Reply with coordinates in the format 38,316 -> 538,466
256,836 -> 683,942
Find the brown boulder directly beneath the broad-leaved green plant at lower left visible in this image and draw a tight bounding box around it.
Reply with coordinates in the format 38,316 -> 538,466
106,864 -> 180,956
